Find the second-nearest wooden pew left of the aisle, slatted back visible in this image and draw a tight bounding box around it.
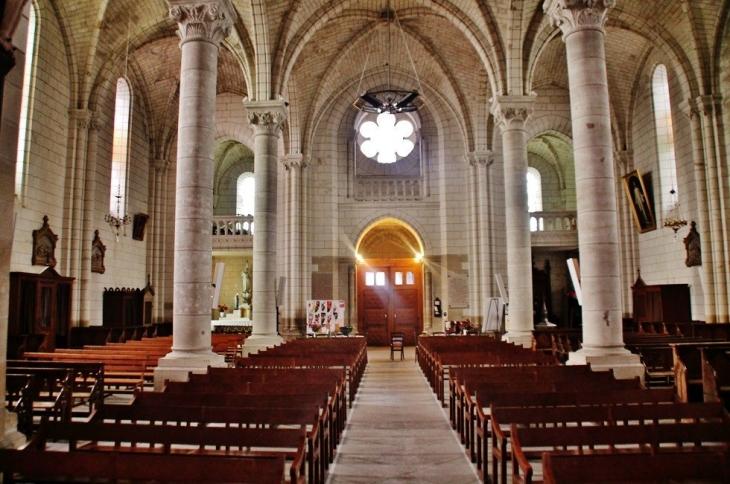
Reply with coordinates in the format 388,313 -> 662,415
25,422 -> 306,484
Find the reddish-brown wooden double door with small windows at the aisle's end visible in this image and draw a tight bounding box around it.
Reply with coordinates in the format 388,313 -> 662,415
357,260 -> 423,346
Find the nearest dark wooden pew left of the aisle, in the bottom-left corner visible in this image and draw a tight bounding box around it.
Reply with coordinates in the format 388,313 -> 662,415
0,449 -> 285,484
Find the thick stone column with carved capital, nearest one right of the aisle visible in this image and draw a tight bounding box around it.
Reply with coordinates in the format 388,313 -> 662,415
543,0 -> 644,378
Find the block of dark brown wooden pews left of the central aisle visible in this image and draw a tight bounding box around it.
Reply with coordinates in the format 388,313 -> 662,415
0,338 -> 367,483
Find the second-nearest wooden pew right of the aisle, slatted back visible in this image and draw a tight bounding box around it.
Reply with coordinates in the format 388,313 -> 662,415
510,423 -> 730,484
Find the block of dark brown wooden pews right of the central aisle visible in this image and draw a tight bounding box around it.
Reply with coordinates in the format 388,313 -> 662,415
419,338 -> 730,483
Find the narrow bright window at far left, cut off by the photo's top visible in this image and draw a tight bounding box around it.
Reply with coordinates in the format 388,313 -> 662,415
15,2 -> 36,197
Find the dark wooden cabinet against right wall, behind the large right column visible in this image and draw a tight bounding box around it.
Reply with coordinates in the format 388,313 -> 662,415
632,277 -> 692,323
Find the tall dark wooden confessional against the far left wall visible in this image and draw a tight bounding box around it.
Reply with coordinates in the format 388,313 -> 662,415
8,267 -> 74,351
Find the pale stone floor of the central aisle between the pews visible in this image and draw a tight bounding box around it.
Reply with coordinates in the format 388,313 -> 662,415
327,347 -> 480,484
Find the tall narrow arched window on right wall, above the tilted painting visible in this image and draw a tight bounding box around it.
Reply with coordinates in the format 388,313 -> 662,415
651,64 -> 677,211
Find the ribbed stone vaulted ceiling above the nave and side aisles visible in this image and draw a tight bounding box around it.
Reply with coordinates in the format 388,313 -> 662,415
45,0 -> 728,155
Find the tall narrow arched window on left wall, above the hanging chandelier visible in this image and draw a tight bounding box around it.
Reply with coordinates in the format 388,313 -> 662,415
109,77 -> 132,213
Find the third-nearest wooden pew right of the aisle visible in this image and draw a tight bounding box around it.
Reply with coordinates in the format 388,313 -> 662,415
490,403 -> 730,483
